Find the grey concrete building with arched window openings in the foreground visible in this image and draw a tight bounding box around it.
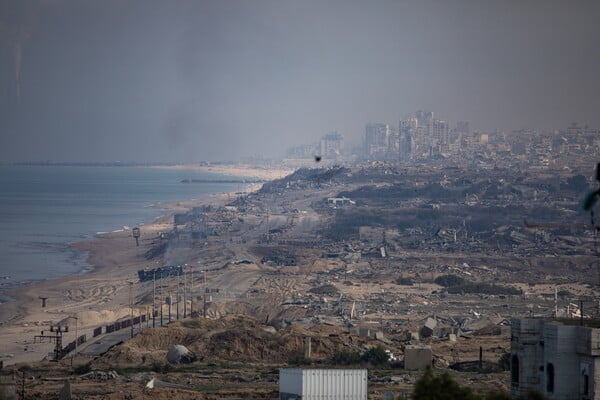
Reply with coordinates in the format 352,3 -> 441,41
511,319 -> 600,400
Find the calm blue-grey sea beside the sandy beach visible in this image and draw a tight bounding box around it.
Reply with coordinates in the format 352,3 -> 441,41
0,166 -> 242,288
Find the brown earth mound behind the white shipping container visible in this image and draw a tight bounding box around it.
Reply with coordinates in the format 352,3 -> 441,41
99,316 -> 364,365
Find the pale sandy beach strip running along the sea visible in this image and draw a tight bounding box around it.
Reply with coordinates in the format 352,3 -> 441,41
0,165 -> 290,365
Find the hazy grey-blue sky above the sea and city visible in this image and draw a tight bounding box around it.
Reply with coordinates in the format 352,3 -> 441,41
0,0 -> 600,162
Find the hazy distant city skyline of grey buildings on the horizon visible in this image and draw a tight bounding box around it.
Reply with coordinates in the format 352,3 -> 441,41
287,111 -> 600,170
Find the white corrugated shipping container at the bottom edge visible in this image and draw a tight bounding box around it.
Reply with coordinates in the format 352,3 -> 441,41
279,368 -> 367,400
